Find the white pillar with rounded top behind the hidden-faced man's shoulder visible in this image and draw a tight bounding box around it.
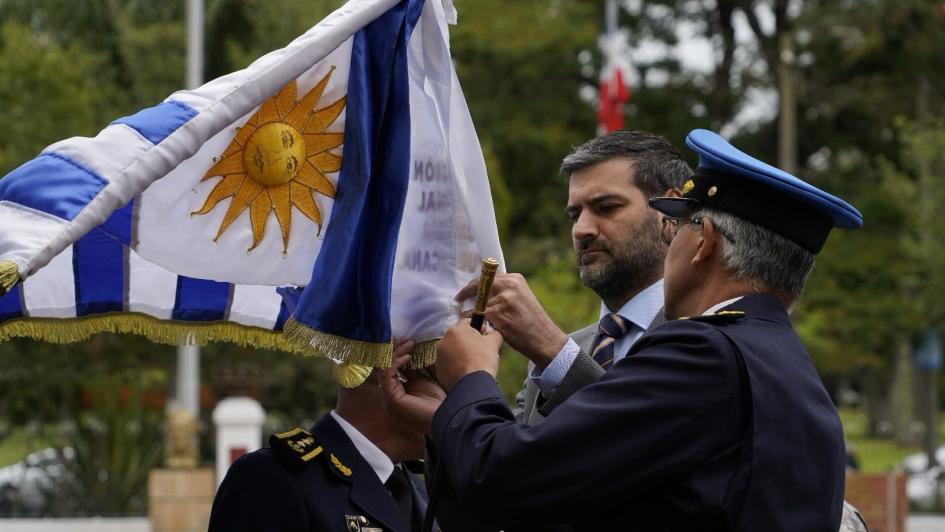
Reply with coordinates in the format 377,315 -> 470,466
213,397 -> 266,486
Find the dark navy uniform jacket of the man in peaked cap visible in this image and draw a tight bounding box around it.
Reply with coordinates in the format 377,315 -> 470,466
433,294 -> 845,532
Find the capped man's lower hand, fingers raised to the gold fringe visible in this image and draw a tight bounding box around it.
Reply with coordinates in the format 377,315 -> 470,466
380,342 -> 446,436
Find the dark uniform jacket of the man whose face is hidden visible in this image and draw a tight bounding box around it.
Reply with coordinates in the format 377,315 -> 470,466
209,414 -> 426,532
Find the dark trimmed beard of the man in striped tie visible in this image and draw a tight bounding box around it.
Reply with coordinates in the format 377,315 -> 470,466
577,211 -> 666,310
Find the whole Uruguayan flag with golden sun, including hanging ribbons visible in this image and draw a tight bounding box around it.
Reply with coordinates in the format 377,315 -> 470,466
0,0 -> 501,378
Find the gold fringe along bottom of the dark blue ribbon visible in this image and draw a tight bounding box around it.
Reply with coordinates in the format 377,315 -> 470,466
283,318 -> 394,368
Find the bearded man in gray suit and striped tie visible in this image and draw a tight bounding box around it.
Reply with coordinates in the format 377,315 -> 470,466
457,130 -> 692,425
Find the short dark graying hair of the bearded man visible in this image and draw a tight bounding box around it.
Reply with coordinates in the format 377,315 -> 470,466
561,129 -> 692,198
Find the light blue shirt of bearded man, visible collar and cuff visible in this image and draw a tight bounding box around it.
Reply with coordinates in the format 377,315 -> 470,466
529,279 -> 663,397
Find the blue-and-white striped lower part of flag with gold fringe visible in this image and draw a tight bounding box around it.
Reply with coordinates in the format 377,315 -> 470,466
0,220 -> 296,350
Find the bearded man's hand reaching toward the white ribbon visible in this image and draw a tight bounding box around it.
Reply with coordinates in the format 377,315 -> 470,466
455,273 -> 568,369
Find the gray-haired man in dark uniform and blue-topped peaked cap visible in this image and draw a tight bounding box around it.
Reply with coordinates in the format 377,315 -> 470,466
383,130 -> 862,532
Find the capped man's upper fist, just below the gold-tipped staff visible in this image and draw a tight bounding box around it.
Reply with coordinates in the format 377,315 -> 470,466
436,319 -> 502,392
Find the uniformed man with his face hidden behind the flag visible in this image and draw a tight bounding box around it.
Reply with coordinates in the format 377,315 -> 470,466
209,343 -> 436,532
